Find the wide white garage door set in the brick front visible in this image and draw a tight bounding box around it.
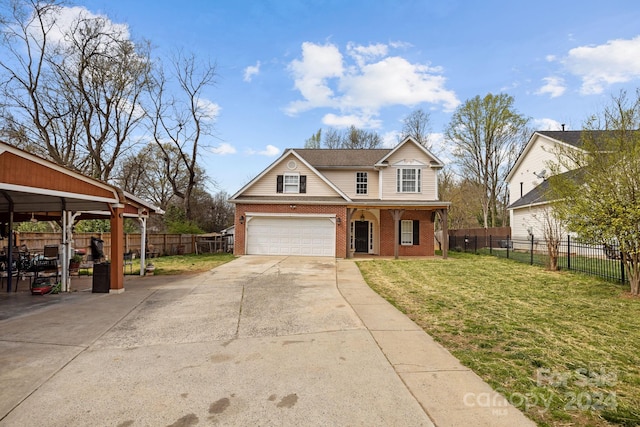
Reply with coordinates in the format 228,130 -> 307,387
247,217 -> 336,256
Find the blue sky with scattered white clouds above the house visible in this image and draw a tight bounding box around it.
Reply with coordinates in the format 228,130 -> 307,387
77,0 -> 640,194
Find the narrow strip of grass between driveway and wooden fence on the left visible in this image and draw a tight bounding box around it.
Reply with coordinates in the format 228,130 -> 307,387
80,253 -> 234,275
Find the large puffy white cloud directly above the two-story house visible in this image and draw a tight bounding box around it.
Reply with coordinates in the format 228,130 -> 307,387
286,42 -> 460,120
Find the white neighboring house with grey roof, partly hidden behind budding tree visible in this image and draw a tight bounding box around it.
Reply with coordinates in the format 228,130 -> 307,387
506,131 -> 582,239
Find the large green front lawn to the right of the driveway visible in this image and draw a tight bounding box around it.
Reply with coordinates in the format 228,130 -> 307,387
358,253 -> 640,426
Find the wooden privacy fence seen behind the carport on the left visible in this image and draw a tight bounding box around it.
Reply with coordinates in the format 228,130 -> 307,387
9,233 -> 198,258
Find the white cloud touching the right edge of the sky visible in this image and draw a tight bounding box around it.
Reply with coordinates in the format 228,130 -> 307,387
563,36 -> 640,94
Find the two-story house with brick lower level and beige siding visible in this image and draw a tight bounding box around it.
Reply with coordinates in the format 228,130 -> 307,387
230,138 -> 450,258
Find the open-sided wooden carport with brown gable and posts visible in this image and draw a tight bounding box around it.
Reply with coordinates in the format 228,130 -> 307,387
0,141 -> 162,292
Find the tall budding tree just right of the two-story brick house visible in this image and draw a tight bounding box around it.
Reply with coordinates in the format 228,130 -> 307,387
445,94 -> 528,228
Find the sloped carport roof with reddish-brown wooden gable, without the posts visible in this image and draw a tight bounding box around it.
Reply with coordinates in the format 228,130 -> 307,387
0,141 -> 162,222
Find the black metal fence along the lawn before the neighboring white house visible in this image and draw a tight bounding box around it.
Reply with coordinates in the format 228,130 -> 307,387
449,236 -> 629,283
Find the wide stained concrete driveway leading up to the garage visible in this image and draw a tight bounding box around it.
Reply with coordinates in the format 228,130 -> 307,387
0,256 -> 534,427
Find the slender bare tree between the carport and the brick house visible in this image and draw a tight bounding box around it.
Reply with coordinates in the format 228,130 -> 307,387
149,53 -> 217,220
